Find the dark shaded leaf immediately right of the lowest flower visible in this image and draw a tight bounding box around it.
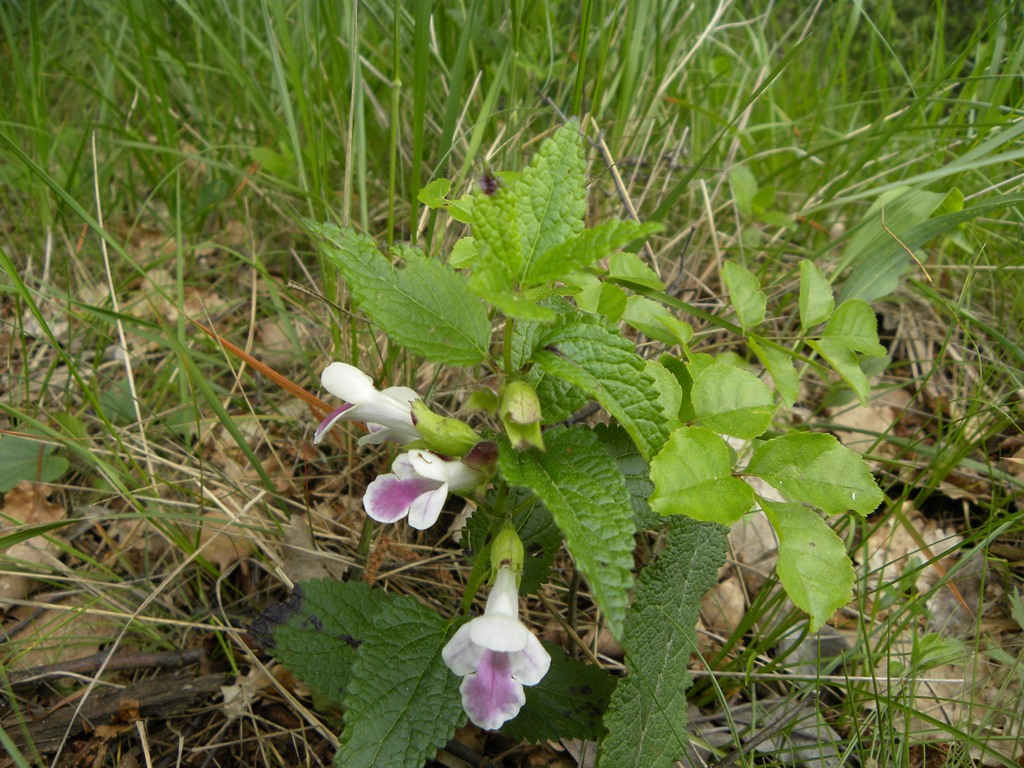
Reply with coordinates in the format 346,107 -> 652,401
502,643 -> 615,742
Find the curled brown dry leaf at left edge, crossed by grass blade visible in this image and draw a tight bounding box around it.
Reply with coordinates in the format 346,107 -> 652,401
0,480 -> 67,610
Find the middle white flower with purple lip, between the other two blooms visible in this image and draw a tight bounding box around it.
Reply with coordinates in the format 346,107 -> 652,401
362,451 -> 483,530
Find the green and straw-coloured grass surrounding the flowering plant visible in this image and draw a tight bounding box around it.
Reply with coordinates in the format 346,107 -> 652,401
0,0 -> 1024,766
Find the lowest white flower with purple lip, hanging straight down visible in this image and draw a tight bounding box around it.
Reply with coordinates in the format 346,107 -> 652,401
441,568 -> 551,729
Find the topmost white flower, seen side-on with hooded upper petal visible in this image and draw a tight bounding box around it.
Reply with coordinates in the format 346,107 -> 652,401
313,362 -> 420,445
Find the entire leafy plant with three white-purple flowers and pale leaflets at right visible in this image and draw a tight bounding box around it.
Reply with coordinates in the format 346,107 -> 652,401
250,122 -> 885,768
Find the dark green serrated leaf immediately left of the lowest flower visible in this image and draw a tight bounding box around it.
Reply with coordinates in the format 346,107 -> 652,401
334,597 -> 466,768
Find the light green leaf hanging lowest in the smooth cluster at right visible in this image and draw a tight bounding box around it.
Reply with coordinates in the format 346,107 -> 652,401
761,500 -> 854,632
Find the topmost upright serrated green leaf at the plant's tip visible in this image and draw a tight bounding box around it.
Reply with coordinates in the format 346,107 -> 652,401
515,120 -> 587,286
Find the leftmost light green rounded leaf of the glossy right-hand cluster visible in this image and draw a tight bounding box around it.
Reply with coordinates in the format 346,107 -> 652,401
650,427 -> 754,525
